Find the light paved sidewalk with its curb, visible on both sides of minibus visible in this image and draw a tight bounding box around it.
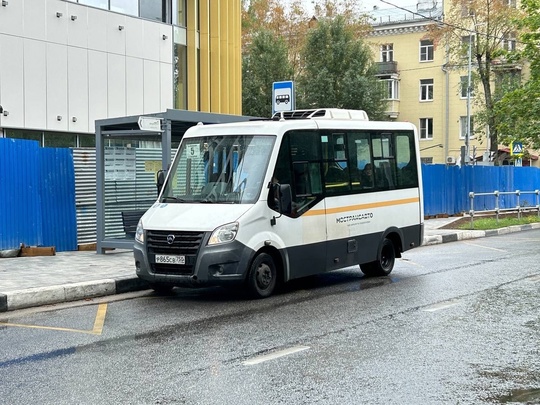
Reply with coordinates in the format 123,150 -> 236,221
0,217 -> 540,312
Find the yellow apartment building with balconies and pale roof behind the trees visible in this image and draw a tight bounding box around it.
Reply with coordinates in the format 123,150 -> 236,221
368,0 -> 537,165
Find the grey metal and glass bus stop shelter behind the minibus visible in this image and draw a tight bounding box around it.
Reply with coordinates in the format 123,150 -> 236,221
96,110 -> 253,254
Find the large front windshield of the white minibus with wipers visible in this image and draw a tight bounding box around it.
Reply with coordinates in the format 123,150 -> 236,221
161,135 -> 275,204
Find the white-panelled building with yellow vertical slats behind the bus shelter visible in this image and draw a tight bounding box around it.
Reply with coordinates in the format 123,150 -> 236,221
0,0 -> 242,147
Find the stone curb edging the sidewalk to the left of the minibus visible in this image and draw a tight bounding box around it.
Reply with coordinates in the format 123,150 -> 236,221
0,276 -> 148,312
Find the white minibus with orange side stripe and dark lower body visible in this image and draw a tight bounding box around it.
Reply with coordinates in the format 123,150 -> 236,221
134,109 -> 424,298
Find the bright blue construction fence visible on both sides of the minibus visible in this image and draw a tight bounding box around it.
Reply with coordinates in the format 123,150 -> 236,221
0,138 -> 540,252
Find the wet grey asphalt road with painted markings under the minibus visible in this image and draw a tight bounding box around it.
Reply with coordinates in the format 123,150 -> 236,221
0,230 -> 540,405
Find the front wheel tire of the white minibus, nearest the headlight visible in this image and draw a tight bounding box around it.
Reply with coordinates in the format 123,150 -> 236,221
247,253 -> 277,298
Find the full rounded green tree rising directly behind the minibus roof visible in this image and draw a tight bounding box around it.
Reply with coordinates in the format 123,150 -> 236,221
297,16 -> 386,119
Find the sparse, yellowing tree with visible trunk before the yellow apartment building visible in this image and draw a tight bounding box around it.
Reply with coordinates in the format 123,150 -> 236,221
431,0 -> 521,161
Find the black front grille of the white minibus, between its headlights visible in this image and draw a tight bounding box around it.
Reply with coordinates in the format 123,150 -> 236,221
146,231 -> 204,256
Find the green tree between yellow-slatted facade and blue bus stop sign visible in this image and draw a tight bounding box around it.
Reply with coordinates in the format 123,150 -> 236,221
242,31 -> 292,117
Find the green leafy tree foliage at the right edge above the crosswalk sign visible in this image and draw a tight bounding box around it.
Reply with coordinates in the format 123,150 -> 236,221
495,0 -> 540,149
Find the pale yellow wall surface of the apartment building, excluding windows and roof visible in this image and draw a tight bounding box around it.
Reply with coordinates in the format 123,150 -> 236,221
368,23 -> 488,163
